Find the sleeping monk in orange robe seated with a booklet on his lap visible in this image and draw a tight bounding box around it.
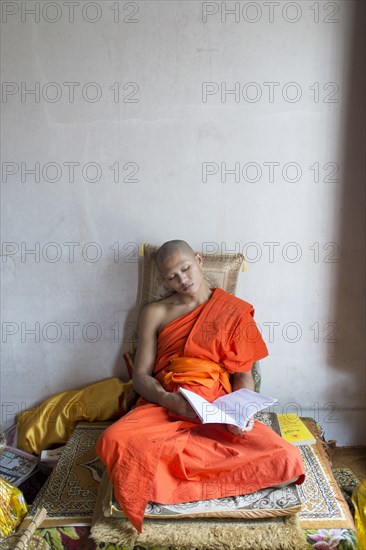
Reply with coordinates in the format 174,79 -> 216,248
96,240 -> 305,532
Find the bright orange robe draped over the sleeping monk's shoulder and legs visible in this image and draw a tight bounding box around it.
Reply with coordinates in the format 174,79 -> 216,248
96,288 -> 304,532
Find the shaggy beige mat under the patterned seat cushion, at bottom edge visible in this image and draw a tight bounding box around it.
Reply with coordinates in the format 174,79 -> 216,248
91,476 -> 307,550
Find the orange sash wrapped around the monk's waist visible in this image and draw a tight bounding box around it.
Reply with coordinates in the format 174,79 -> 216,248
162,357 -> 232,393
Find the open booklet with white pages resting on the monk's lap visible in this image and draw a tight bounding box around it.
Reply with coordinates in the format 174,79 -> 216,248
179,388 -> 278,428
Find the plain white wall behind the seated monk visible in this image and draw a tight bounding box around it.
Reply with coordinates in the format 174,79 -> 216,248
1,0 -> 365,444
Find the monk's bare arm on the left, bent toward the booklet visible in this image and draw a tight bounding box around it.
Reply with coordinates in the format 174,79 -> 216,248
133,304 -> 196,418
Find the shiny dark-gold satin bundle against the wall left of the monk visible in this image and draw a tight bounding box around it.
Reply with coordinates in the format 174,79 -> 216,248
17,378 -> 134,454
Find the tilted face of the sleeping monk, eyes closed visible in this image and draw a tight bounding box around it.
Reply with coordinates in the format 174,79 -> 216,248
160,251 -> 203,294
